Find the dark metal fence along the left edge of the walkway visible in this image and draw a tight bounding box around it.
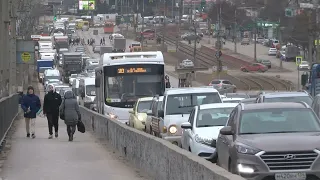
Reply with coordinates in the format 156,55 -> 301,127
0,94 -> 19,148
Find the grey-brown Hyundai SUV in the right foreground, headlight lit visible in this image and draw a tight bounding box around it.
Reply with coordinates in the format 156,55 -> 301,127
216,102 -> 320,180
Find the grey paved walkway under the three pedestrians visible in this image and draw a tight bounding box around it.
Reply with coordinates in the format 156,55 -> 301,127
0,85 -> 151,180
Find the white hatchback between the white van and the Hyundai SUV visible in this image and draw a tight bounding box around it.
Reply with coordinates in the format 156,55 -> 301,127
181,103 -> 238,161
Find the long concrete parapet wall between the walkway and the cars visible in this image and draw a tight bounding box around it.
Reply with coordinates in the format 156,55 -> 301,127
80,107 -> 244,180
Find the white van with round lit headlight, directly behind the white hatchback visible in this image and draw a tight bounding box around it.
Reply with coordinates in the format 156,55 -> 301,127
148,87 -> 222,146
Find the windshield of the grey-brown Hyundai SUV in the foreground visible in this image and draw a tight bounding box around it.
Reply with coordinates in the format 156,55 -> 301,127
239,108 -> 320,134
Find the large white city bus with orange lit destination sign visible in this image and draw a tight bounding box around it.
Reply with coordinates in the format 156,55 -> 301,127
95,51 -> 165,123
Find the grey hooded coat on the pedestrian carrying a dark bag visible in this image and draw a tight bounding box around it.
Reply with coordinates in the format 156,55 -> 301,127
60,91 -> 81,125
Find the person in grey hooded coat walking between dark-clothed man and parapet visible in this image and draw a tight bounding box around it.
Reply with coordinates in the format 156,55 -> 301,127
60,91 -> 81,141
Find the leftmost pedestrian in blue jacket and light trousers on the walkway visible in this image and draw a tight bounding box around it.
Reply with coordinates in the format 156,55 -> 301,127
21,86 -> 41,138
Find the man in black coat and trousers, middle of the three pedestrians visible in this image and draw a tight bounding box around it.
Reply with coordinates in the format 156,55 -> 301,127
43,85 -> 62,139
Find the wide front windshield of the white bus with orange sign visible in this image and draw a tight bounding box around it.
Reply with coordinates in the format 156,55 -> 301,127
104,64 -> 165,108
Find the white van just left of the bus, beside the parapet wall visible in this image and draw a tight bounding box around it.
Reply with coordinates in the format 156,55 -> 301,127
79,77 -> 96,108
